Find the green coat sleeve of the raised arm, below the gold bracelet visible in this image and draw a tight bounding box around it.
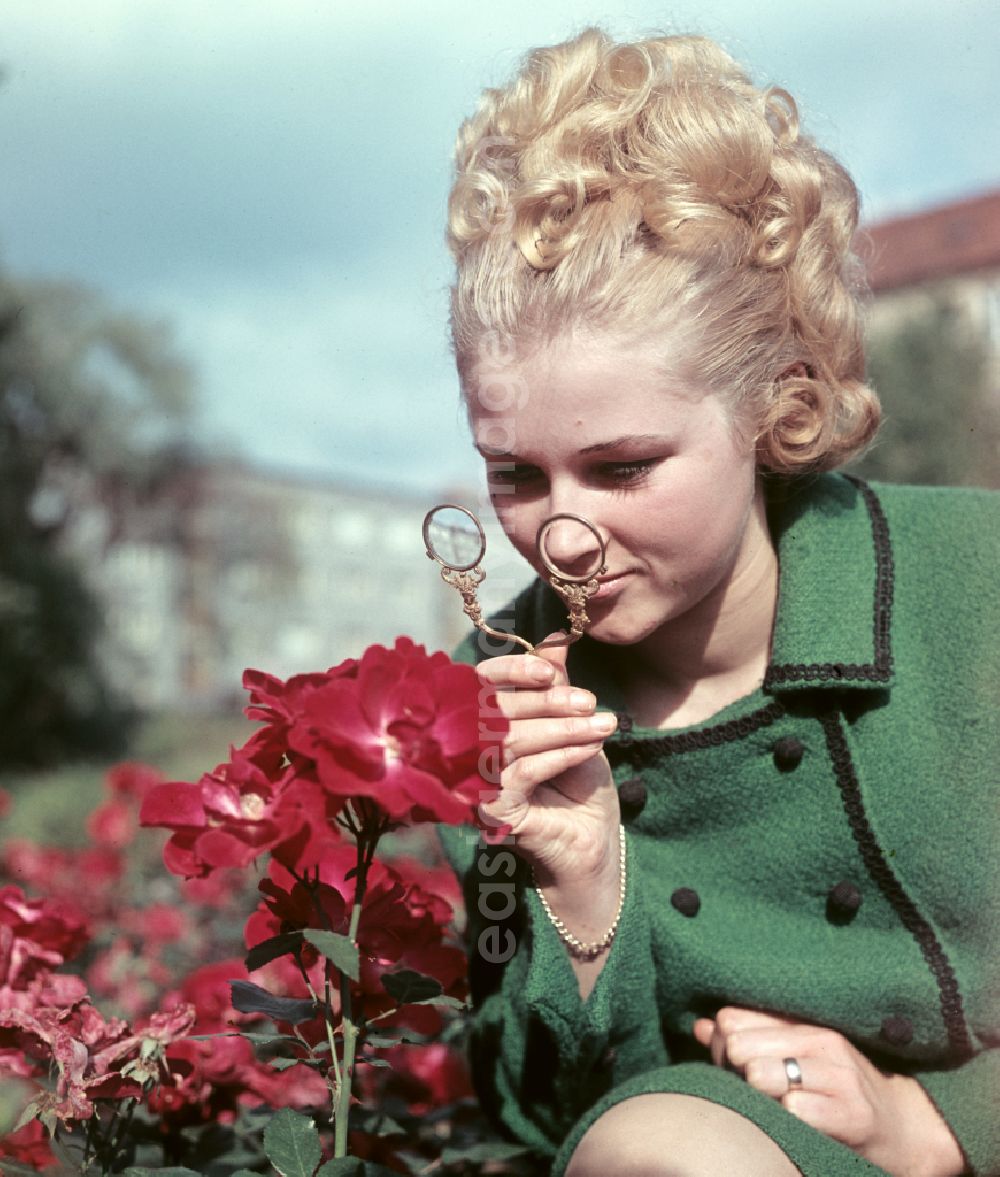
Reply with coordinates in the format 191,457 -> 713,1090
441,830 -> 668,1157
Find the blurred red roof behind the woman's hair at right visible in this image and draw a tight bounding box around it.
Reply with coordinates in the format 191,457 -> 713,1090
858,189 -> 1000,294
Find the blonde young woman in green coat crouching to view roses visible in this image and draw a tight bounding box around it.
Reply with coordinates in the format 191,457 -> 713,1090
437,29 -> 1000,1177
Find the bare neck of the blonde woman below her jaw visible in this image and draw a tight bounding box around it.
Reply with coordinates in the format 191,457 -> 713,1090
618,491 -> 778,727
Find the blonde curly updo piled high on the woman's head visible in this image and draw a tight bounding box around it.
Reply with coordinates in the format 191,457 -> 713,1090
448,28 -> 879,476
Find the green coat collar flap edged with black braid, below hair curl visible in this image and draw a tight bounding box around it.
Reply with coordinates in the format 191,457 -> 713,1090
764,476 -> 893,693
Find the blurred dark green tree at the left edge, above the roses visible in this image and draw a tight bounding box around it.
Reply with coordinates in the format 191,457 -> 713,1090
0,275 -> 192,771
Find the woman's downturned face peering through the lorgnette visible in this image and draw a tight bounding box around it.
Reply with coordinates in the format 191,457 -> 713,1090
468,333 -> 766,645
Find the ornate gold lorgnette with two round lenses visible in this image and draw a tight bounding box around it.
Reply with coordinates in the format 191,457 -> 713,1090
424,503 -> 607,653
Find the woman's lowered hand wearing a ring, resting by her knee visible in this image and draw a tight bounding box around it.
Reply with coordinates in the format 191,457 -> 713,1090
694,1006 -> 966,1177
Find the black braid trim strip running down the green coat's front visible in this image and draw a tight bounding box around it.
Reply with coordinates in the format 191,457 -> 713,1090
820,711 -> 974,1057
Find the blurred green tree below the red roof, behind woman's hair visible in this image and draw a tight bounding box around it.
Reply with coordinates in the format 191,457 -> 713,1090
854,295 -> 1000,487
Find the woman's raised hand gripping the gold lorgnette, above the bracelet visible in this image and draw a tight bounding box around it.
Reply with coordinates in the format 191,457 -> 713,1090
478,644 -> 619,886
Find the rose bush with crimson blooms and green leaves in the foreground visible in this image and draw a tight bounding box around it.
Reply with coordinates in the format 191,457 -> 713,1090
0,638 -> 534,1177
